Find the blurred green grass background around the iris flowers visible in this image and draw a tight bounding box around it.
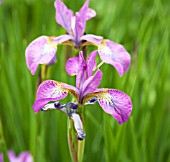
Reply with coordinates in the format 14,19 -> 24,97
0,0 -> 170,162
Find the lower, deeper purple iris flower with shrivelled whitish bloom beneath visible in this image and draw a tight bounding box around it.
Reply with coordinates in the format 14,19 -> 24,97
33,51 -> 132,139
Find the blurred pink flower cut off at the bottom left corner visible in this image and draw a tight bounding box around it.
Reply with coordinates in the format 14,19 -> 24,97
0,151 -> 33,162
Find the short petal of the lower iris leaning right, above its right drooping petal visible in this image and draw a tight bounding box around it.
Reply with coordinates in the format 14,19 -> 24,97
80,70 -> 102,96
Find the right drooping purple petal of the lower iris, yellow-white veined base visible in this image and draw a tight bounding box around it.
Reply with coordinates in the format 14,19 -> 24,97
83,88 -> 132,124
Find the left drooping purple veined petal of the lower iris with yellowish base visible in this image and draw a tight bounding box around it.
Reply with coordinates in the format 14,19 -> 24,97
33,80 -> 78,112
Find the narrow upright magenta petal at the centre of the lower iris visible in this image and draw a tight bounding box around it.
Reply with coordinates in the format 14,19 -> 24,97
76,51 -> 88,89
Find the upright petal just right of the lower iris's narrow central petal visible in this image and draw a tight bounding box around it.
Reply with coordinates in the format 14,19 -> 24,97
86,50 -> 98,78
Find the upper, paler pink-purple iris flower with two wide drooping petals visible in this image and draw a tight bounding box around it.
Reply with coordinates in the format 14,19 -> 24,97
25,0 -> 130,76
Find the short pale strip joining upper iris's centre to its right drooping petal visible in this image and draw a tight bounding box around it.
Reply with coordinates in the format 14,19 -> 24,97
80,34 -> 103,46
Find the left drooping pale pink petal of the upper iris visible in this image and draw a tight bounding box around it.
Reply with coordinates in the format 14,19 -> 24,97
25,36 -> 57,75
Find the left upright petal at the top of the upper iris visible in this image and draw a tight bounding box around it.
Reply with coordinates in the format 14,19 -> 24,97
54,0 -> 73,34
